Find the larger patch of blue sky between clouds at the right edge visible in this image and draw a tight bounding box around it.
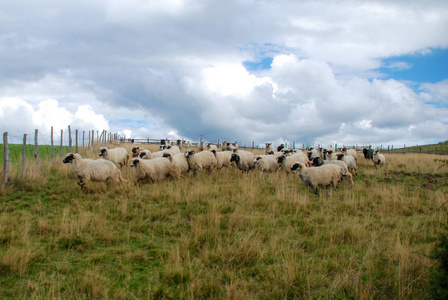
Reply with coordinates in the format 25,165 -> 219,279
379,49 -> 448,83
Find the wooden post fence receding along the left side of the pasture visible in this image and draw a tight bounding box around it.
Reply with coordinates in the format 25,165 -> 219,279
0,126 -> 119,184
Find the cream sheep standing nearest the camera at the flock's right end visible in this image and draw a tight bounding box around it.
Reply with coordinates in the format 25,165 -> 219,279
291,162 -> 342,196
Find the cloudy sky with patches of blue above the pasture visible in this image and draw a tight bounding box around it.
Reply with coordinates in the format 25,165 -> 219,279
0,0 -> 448,147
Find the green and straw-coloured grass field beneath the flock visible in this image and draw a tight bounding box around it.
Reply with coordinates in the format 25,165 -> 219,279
0,145 -> 448,299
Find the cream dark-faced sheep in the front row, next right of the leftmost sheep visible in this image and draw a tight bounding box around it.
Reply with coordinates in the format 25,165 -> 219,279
131,157 -> 180,183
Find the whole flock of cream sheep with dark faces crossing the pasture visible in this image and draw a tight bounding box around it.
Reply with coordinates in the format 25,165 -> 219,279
63,141 -> 386,195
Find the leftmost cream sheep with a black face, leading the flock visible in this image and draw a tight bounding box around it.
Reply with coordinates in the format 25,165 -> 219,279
62,153 -> 127,190
